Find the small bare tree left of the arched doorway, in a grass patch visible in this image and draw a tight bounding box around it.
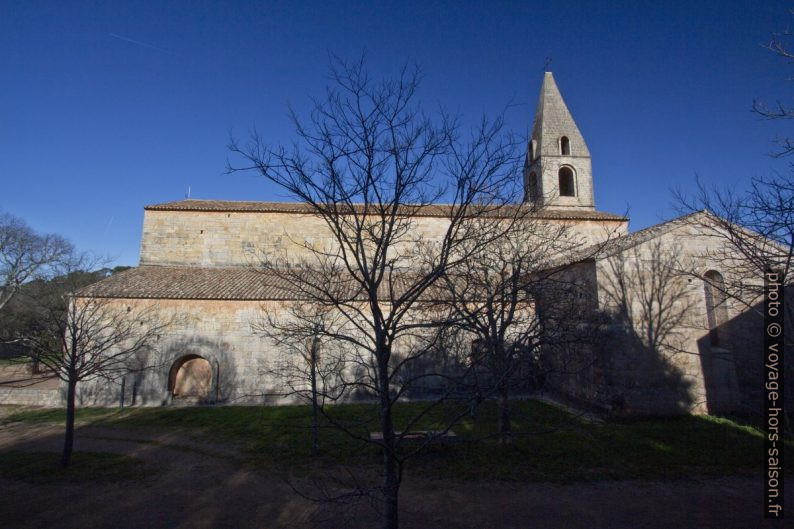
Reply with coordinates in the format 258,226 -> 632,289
21,256 -> 168,467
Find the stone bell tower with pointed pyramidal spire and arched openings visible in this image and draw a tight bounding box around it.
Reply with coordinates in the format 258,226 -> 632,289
524,72 -> 595,210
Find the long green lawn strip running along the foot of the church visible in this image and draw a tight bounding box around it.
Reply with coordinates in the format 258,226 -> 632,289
4,401 -> 794,481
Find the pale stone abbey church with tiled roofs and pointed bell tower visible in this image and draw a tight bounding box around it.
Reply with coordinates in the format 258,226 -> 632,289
69,72 -> 760,413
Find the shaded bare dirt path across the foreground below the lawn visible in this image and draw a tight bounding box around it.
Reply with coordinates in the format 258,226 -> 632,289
0,424 -> 794,529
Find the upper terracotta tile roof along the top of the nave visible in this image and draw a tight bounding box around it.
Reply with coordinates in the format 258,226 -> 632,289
144,199 -> 628,221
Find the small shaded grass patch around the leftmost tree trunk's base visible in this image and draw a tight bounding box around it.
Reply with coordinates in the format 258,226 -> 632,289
0,451 -> 153,484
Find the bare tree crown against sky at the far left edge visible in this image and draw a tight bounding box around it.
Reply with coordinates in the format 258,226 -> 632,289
0,213 -> 73,310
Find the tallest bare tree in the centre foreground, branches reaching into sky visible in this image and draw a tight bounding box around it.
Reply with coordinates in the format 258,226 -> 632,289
229,55 -> 520,528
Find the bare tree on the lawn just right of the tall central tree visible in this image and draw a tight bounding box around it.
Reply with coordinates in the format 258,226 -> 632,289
444,212 -> 597,444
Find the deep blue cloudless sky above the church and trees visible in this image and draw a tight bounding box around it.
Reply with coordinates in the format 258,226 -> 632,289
0,0 -> 794,264
